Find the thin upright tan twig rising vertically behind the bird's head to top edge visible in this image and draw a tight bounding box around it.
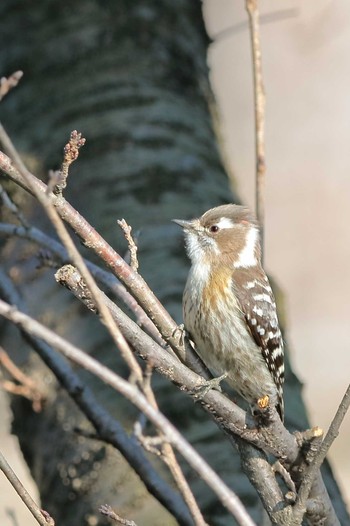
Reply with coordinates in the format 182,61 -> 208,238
246,0 -> 266,260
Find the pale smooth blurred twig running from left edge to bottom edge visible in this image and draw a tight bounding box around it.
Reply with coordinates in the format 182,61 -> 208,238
0,300 -> 256,526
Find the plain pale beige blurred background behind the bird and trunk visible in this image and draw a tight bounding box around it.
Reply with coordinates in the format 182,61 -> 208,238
0,0 -> 350,526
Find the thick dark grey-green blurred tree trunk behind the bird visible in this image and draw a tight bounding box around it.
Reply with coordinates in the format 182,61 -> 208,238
0,0 -> 348,526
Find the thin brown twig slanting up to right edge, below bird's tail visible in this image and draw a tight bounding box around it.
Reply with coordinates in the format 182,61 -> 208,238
293,385 -> 350,519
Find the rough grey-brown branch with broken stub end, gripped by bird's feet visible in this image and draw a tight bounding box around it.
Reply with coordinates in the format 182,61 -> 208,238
55,265 -> 299,462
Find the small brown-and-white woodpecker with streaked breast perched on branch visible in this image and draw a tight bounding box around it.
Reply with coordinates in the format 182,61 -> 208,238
173,204 -> 284,421
